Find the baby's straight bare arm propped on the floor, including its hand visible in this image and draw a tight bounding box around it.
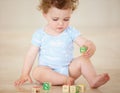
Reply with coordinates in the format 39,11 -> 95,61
15,45 -> 39,86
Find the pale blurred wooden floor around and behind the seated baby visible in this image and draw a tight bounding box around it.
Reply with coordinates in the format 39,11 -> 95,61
0,28 -> 120,93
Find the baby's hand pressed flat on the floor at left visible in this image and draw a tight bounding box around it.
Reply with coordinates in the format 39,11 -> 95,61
14,75 -> 32,86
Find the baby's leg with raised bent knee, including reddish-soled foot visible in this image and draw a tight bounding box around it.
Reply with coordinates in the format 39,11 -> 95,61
69,56 -> 109,88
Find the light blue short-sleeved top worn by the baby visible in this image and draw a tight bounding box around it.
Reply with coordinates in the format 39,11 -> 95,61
32,27 -> 80,68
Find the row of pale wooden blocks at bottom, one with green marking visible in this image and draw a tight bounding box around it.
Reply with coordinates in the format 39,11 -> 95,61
62,85 -> 85,93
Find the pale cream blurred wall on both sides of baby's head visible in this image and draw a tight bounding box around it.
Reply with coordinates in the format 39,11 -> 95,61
0,0 -> 120,28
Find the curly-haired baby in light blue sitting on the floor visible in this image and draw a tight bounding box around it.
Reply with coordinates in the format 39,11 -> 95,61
15,0 -> 109,88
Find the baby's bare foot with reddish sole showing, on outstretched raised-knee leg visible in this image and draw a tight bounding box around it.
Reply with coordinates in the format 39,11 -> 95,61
91,73 -> 110,88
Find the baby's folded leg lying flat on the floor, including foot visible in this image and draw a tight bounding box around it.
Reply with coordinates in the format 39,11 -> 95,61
33,66 -> 74,85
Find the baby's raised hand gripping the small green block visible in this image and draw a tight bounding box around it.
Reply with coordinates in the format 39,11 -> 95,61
83,41 -> 96,58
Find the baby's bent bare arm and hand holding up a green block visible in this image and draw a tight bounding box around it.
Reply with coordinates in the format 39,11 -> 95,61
75,36 -> 96,57
